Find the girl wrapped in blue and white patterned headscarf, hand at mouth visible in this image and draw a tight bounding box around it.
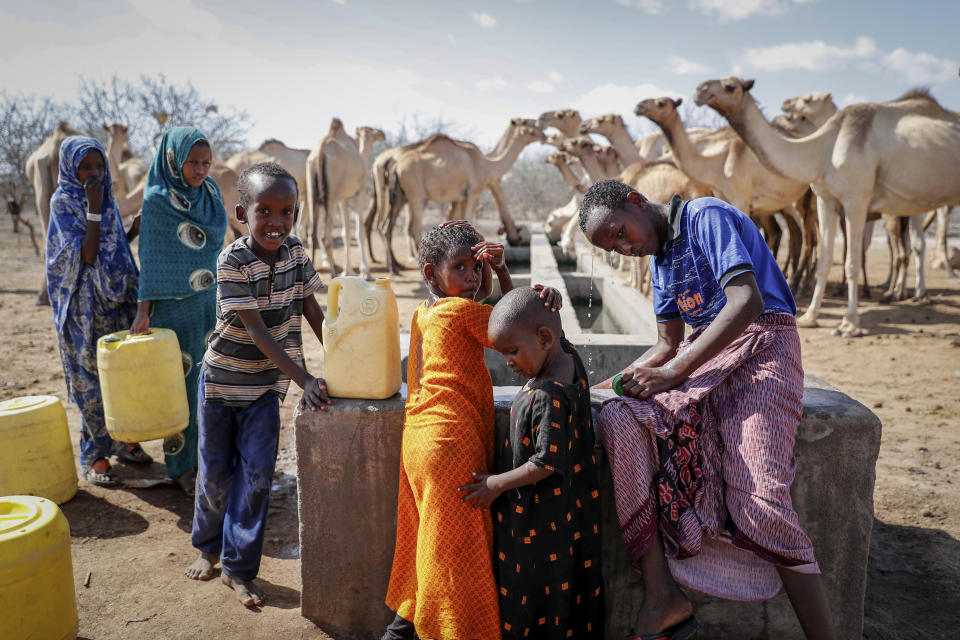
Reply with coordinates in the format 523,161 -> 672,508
46,136 -> 142,486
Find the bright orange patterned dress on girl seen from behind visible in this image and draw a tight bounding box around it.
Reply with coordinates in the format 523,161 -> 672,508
387,298 -> 500,640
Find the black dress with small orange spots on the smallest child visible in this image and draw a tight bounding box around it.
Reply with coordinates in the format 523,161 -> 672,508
493,341 -> 604,640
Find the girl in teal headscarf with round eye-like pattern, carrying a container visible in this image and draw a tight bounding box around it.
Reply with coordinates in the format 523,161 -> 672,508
130,127 -> 227,495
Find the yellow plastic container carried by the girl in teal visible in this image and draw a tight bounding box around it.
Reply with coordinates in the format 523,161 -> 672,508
97,329 -> 190,442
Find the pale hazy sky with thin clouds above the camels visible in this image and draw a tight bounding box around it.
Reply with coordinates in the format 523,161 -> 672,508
0,0 -> 960,148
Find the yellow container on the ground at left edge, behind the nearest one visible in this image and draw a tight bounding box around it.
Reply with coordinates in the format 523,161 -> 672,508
0,396 -> 77,504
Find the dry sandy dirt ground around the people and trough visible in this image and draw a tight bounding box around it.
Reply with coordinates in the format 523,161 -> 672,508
0,214 -> 960,640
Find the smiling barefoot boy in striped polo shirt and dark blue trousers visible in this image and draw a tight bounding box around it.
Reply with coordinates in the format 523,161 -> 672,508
186,162 -> 330,607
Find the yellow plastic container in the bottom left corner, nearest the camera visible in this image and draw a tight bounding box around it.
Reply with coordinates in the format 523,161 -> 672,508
0,496 -> 79,640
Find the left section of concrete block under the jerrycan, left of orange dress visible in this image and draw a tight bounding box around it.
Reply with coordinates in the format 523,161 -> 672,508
294,388 -> 406,638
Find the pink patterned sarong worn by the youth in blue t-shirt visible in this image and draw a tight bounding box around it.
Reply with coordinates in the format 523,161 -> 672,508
597,314 -> 820,600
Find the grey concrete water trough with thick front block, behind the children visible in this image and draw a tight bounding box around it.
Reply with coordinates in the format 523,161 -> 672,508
294,228 -> 880,639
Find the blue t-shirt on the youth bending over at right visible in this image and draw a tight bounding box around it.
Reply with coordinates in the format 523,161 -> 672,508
650,196 -> 797,327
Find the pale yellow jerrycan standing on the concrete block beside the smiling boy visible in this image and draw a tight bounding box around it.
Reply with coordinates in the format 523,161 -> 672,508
323,276 -> 400,400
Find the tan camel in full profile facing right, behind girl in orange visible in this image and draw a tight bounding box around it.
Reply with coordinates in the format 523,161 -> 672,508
386,124 -> 544,272
